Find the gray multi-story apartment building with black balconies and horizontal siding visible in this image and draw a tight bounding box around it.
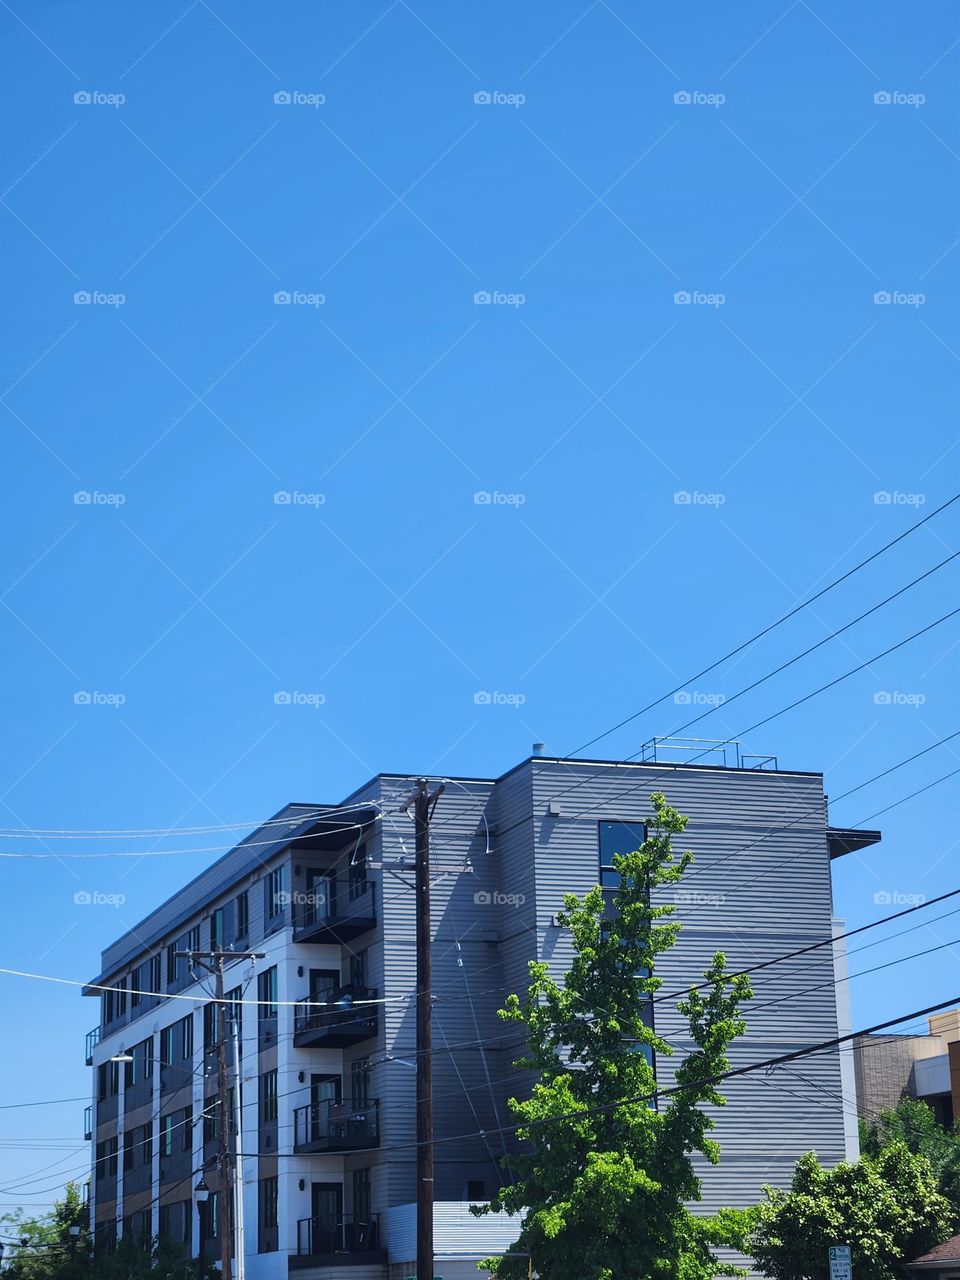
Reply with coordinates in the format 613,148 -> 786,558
87,755 -> 879,1280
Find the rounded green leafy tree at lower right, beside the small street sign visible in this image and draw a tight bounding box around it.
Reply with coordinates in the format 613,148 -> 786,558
746,1142 -> 952,1280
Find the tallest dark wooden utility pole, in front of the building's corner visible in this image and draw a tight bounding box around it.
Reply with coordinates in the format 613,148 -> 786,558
413,778 -> 443,1280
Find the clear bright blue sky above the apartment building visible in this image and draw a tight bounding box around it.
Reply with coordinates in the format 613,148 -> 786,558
0,0 -> 960,1207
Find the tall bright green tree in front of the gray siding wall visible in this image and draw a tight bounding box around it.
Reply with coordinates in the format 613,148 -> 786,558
475,792 -> 750,1280
